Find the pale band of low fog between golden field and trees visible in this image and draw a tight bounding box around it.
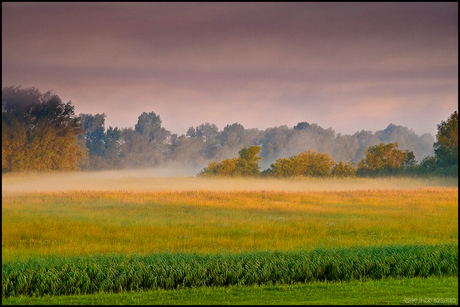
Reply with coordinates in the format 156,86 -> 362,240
2,168 -> 458,195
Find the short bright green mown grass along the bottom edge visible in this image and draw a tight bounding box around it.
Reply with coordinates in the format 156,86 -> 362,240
2,277 -> 458,305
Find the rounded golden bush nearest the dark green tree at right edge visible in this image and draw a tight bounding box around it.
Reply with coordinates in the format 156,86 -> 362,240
357,142 -> 416,176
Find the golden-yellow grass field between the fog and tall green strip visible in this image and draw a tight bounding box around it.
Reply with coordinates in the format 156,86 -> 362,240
2,187 -> 458,261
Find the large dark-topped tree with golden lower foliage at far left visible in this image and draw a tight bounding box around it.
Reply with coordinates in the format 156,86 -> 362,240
2,86 -> 85,172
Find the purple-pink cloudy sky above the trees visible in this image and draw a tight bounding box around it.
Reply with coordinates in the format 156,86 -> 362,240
2,2 -> 458,136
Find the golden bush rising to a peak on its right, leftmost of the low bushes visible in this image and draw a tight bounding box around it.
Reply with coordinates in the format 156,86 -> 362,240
198,146 -> 262,177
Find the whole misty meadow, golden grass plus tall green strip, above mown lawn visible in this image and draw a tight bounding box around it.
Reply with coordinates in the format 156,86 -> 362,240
2,173 -> 458,303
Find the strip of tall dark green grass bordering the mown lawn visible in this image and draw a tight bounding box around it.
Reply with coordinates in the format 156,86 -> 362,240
2,244 -> 458,298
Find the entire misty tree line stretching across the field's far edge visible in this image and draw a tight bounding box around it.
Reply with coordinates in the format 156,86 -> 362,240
2,86 -> 458,176
